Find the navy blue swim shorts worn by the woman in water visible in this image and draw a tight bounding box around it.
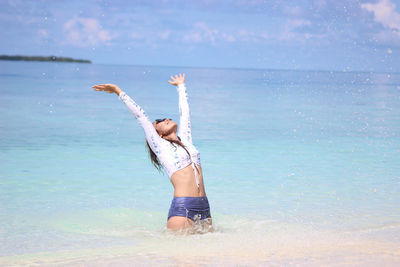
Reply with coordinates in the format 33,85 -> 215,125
168,196 -> 211,221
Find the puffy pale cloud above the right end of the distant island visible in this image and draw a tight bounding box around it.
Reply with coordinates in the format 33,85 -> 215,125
64,17 -> 113,47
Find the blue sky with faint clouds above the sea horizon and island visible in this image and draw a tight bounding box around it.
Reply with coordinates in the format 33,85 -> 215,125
0,0 -> 400,72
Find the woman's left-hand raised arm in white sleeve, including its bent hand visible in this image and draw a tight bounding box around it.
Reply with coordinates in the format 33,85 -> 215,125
93,84 -> 162,155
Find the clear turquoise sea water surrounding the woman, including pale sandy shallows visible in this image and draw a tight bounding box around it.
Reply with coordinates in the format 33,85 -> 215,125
0,61 -> 400,266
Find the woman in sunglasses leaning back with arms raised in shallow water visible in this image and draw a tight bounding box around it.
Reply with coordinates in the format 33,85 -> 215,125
93,74 -> 213,232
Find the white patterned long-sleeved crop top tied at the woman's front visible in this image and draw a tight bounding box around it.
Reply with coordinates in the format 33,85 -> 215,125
119,84 -> 201,187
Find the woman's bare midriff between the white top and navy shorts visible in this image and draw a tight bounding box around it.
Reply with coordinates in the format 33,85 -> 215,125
171,164 -> 206,197
